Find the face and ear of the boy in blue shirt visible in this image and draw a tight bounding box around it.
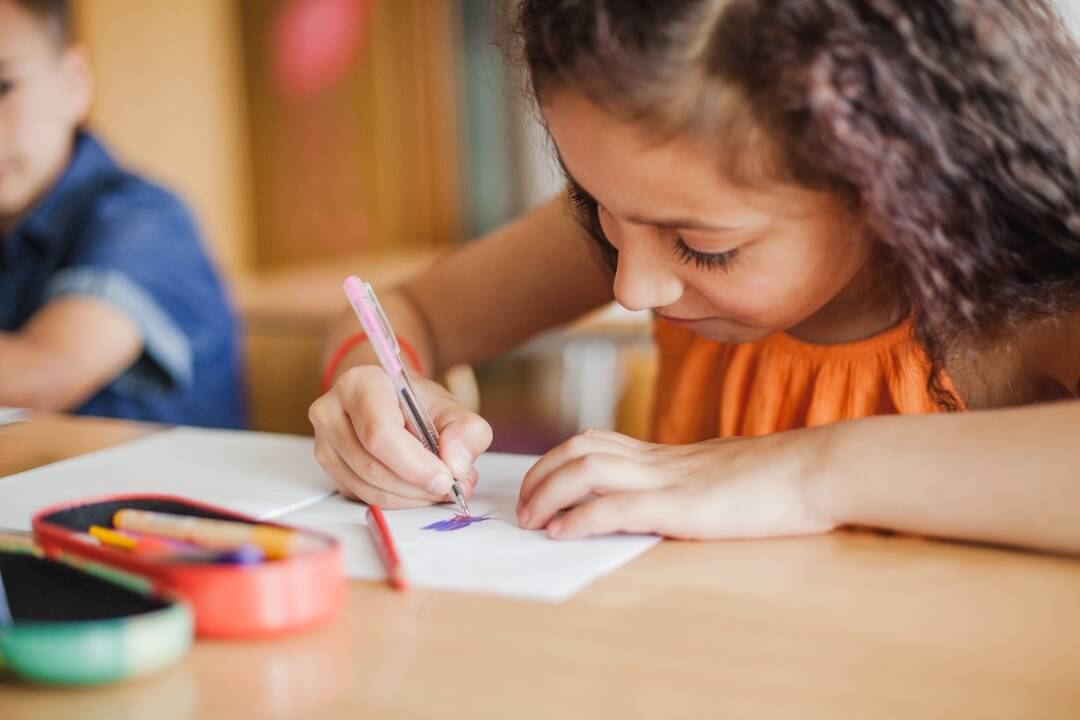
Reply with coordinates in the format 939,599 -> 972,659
0,0 -> 92,237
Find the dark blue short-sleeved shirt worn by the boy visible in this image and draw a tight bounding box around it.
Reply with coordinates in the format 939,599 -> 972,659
0,132 -> 243,427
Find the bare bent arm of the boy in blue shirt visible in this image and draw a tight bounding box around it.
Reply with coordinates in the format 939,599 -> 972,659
0,296 -> 143,410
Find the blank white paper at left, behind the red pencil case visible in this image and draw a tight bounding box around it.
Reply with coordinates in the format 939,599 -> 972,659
0,427 -> 334,530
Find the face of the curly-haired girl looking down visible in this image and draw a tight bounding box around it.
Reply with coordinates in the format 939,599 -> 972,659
543,91 -> 880,342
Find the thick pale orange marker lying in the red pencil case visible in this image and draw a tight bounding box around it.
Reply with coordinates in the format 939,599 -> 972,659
112,510 -> 325,560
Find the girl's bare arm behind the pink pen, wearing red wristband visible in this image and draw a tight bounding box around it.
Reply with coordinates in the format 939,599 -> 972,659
327,195 -> 612,375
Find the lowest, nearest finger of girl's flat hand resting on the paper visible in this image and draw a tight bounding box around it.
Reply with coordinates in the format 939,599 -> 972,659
548,490 -> 677,540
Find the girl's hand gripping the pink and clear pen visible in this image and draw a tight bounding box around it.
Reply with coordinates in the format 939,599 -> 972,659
308,365 -> 491,507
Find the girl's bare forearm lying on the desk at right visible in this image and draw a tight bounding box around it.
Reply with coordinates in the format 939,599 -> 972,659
808,402 -> 1080,553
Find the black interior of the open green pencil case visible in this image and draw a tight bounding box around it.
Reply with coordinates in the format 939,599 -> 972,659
0,552 -> 168,623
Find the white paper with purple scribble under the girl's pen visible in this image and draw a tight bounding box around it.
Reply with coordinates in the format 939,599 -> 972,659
278,452 -> 659,602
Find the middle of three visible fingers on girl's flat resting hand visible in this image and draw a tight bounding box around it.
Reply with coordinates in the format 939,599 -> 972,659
517,452 -> 659,529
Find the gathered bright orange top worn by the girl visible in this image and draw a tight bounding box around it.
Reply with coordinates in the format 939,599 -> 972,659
652,320 -> 951,444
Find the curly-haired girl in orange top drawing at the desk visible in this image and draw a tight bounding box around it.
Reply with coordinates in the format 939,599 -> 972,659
310,0 -> 1080,552
